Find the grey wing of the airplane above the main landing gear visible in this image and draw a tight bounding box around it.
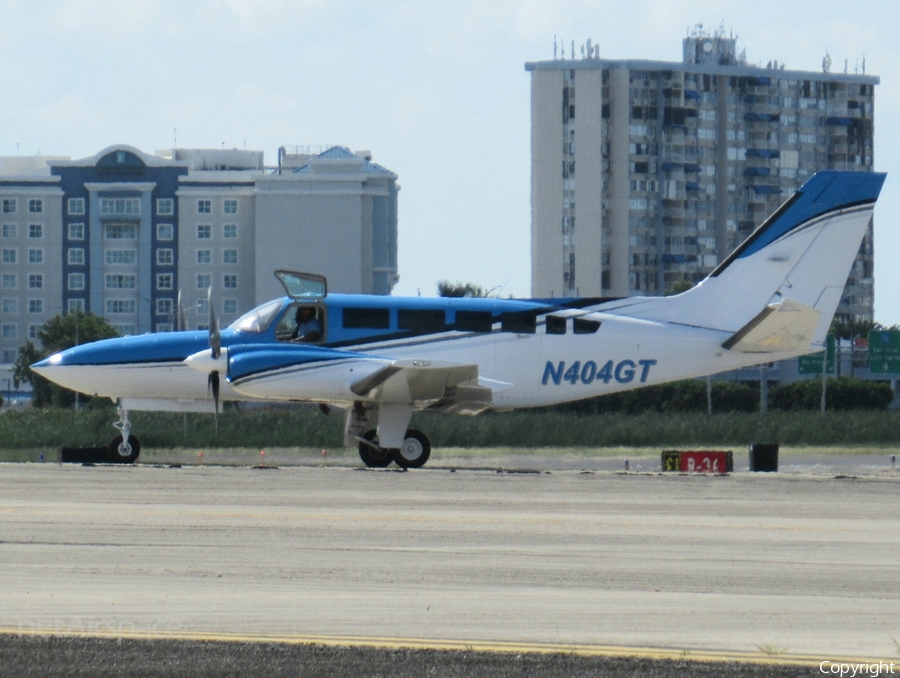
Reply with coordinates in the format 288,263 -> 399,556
350,360 -> 496,414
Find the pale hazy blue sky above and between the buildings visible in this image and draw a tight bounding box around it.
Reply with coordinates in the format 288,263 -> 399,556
0,0 -> 900,325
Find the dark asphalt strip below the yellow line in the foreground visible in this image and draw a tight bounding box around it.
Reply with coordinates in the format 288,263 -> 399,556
0,637 -> 832,678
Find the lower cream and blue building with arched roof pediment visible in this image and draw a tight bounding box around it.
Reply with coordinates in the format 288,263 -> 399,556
0,145 -> 399,380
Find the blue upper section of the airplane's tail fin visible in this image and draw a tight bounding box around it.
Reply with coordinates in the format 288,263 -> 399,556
710,170 -> 887,276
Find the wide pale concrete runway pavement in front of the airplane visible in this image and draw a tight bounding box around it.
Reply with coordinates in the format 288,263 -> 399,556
0,464 -> 900,672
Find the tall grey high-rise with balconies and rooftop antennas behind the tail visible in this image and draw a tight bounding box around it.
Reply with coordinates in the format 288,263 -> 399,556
525,29 -> 879,320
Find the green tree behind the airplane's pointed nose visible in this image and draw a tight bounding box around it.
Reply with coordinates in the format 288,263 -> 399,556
13,311 -> 119,407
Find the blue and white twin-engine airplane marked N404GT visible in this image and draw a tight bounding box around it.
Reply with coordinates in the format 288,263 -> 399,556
32,171 -> 885,468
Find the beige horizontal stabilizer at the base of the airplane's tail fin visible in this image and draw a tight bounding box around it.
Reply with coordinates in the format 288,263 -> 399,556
722,299 -> 821,353
